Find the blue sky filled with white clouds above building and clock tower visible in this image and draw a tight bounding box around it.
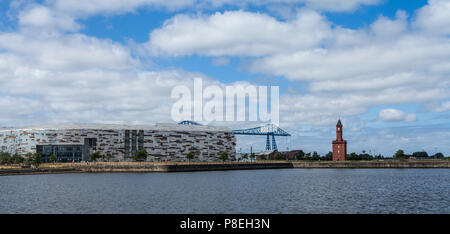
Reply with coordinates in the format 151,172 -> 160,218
0,0 -> 450,157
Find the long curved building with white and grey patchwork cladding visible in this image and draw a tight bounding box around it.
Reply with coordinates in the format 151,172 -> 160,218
0,124 -> 236,162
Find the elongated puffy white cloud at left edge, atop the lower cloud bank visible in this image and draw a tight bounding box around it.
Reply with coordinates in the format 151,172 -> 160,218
0,31 -> 140,70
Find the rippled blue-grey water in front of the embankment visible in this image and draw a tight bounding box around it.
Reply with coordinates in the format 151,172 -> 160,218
0,169 -> 450,214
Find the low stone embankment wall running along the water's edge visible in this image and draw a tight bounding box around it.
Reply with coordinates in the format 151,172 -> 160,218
0,160 -> 450,175
